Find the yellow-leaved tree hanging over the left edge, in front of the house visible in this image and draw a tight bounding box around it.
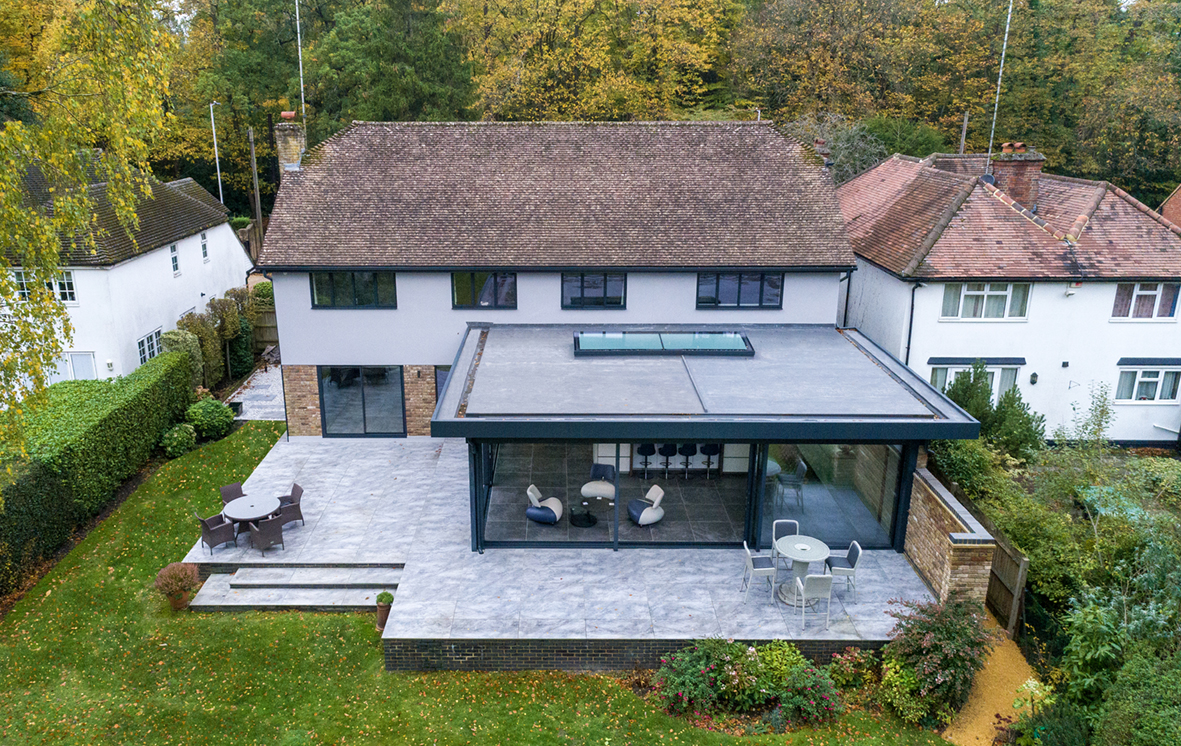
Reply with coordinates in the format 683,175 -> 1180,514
0,0 -> 172,444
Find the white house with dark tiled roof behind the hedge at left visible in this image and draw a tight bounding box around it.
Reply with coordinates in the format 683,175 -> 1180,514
13,174 -> 252,375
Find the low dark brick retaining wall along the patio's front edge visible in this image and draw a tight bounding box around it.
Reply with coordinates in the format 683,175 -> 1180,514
383,639 -> 886,670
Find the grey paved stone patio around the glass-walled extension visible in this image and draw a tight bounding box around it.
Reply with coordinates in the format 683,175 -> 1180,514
185,438 -> 929,641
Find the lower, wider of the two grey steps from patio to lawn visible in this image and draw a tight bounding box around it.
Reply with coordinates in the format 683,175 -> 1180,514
189,572 -> 393,611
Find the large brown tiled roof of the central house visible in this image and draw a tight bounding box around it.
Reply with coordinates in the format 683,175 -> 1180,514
259,122 -> 854,268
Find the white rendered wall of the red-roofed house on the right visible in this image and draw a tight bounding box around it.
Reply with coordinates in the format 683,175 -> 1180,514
907,279 -> 1181,443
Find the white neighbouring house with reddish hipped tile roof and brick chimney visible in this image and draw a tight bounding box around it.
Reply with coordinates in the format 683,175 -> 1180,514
837,143 -> 1181,446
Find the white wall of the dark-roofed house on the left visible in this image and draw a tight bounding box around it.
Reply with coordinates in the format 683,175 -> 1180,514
64,223 -> 250,378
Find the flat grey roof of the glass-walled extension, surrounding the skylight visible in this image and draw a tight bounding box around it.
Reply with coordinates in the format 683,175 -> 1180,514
431,323 -> 980,443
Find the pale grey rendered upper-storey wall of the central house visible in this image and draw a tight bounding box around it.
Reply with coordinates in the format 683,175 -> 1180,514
273,271 -> 840,365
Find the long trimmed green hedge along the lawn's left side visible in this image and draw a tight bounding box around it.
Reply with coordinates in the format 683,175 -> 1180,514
0,352 -> 191,595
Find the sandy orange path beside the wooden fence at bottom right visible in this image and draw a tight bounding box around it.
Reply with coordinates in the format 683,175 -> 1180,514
942,614 -> 1035,746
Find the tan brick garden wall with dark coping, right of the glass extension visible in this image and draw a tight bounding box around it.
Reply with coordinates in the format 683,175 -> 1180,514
906,467 -> 996,603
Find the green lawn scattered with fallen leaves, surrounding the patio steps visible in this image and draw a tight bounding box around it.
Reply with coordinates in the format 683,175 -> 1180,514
0,423 -> 944,746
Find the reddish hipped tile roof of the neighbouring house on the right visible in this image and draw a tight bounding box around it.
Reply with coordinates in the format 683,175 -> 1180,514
837,153 -> 1181,280
